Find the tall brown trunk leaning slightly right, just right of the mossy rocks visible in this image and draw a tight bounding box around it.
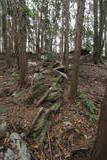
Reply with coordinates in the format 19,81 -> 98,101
68,0 -> 85,102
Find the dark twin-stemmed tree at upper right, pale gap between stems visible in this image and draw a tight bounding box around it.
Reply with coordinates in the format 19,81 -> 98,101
94,0 -> 105,64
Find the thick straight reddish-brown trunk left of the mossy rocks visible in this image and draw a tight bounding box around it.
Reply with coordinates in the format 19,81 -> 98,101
18,0 -> 28,87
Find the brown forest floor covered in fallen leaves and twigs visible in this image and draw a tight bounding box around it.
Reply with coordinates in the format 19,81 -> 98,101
0,55 -> 107,160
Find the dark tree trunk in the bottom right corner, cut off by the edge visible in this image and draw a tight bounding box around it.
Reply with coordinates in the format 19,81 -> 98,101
90,80 -> 107,160
